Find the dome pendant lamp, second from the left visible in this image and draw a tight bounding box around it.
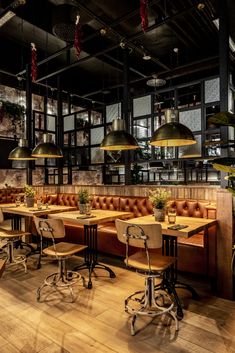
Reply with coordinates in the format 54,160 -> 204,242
32,134 -> 63,158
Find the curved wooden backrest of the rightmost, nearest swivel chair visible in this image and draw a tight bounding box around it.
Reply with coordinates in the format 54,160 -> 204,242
115,219 -> 162,249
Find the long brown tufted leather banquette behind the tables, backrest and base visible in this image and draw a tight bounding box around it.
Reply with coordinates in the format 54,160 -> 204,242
42,194 -> 216,275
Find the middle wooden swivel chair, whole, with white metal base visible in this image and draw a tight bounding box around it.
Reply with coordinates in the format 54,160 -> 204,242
34,217 -> 87,302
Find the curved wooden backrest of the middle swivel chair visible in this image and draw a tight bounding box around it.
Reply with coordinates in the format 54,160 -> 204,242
34,217 -> 65,239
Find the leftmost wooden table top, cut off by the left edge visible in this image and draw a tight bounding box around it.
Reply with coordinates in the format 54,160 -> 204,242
0,203 -> 77,217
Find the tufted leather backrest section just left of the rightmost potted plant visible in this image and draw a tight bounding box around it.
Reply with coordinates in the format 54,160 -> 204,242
120,197 -> 153,217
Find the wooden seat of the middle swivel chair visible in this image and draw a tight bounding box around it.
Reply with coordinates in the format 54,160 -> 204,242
43,242 -> 87,257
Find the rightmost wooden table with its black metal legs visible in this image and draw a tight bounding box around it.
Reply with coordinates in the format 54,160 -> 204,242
127,215 -> 218,318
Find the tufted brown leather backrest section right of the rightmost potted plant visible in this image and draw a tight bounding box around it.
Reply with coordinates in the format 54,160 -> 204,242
169,200 -> 209,218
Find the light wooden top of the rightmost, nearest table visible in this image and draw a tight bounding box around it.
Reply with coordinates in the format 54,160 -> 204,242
127,215 -> 218,238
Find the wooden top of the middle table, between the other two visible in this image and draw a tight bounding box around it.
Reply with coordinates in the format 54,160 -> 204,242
49,210 -> 132,225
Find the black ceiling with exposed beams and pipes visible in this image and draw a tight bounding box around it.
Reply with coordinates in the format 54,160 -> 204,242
0,0 -> 235,106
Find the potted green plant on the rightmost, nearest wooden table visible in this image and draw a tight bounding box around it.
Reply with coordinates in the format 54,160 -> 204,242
149,189 -> 171,222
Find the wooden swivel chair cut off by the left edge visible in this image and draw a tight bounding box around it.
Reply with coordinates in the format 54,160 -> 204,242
0,208 -> 29,273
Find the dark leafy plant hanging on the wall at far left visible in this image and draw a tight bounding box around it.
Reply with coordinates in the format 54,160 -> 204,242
0,100 -> 25,135
